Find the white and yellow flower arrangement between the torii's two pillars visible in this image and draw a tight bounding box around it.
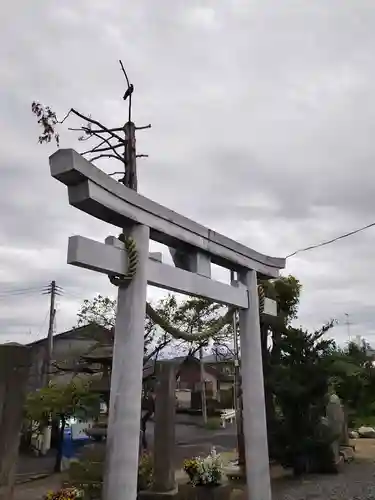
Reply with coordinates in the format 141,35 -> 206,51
183,448 -> 223,486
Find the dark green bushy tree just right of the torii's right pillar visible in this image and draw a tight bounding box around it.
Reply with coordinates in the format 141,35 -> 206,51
271,321 -> 334,473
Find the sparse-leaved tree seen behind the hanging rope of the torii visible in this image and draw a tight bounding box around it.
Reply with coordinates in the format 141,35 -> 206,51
78,294 -> 232,446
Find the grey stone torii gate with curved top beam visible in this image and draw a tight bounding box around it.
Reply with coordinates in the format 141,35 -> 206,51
50,149 -> 285,500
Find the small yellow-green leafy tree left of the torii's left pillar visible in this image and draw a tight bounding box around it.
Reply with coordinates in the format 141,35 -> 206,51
25,382 -> 100,472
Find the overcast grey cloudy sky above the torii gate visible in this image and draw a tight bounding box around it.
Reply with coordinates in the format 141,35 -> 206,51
0,0 -> 375,348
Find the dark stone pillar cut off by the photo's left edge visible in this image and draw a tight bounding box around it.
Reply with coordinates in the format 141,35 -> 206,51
0,344 -> 31,500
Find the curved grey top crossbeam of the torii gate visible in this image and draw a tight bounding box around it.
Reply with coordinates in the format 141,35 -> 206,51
50,149 -> 285,278
